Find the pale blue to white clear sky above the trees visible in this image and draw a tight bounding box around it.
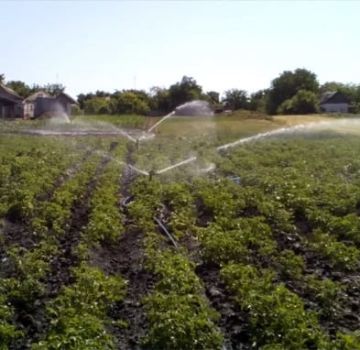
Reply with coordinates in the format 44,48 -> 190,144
0,0 -> 360,95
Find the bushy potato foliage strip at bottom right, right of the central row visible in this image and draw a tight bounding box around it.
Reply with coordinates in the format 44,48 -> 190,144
221,265 -> 327,349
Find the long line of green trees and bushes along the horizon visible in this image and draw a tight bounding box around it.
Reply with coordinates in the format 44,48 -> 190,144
0,68 -> 360,115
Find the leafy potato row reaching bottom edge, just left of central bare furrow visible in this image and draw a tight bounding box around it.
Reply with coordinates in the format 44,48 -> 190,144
33,148 -> 126,350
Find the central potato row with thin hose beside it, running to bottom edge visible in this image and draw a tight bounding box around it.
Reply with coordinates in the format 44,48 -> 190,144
129,181 -> 223,349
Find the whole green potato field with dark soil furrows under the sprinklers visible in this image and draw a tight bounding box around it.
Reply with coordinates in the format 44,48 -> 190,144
0,118 -> 360,350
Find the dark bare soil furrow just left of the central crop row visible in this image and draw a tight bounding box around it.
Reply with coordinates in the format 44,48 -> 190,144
92,147 -> 153,350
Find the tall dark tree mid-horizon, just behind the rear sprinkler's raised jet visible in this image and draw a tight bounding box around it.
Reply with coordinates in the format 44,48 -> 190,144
169,76 -> 202,110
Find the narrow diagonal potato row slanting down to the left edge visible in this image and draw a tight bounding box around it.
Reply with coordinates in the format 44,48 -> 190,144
0,155 -> 104,348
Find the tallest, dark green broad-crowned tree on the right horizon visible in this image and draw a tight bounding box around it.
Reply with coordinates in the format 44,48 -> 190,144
266,69 -> 319,114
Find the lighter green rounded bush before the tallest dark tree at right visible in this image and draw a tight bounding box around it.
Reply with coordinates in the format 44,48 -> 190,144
277,90 -> 319,114
